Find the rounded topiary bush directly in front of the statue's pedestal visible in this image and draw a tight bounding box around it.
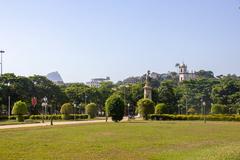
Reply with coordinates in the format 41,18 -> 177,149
137,98 -> 154,120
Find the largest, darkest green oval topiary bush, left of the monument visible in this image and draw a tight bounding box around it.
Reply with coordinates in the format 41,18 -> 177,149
105,95 -> 124,122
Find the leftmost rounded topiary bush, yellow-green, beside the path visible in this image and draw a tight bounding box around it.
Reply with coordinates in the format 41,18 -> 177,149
12,101 -> 28,122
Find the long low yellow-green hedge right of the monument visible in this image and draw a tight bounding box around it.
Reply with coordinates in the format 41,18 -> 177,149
149,114 -> 240,121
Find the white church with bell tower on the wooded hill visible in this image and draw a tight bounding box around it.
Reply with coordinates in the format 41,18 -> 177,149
178,63 -> 196,82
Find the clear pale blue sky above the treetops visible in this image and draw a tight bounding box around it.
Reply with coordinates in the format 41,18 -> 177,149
0,0 -> 240,82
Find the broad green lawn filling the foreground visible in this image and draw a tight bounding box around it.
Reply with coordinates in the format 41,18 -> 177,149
0,121 -> 240,160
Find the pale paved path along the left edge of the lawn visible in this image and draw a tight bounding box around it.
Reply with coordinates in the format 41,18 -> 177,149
0,120 -> 108,130
